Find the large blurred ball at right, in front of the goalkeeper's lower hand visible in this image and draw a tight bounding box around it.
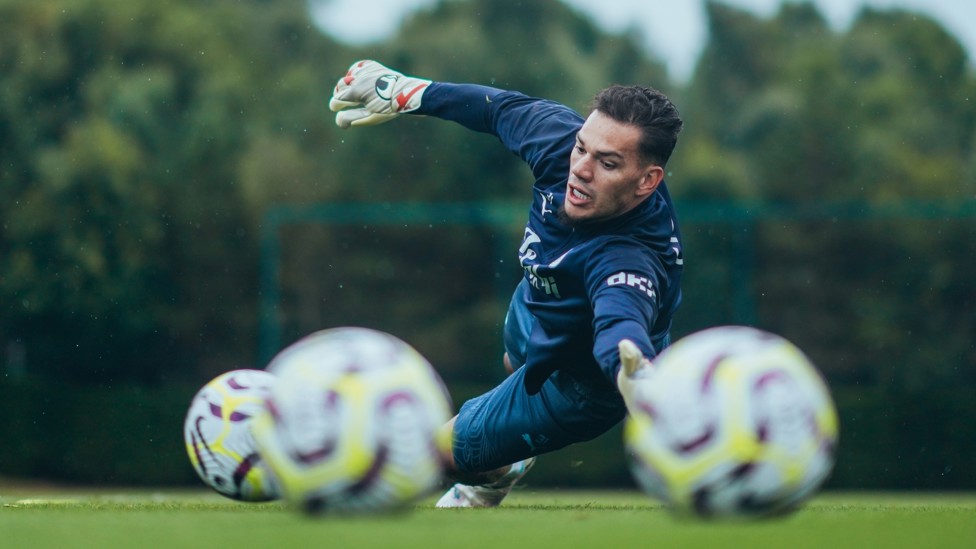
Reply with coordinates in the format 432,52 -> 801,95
624,326 -> 837,517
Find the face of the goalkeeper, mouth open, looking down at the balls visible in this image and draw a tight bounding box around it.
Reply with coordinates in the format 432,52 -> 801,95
563,111 -> 664,223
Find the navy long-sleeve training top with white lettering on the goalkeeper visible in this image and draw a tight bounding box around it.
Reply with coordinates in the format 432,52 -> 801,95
414,82 -> 683,394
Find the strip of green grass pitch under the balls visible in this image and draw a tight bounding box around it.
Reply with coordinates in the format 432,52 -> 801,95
0,485 -> 976,549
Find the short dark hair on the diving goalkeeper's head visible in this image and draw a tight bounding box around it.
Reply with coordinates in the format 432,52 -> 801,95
592,85 -> 684,167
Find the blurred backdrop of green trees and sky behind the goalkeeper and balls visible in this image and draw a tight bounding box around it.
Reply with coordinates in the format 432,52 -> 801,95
0,0 -> 976,490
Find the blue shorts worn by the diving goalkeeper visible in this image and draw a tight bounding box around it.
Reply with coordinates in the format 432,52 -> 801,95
453,280 -> 627,472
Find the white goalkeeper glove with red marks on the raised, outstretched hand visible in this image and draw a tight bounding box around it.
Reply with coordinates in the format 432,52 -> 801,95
329,60 -> 431,128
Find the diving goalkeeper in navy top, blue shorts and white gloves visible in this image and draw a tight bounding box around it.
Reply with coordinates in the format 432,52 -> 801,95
329,61 -> 682,507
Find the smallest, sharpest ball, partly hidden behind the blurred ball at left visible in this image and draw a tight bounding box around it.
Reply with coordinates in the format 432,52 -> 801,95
183,370 -> 278,501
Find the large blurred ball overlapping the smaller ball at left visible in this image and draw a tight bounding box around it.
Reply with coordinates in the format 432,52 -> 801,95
255,328 -> 451,513
